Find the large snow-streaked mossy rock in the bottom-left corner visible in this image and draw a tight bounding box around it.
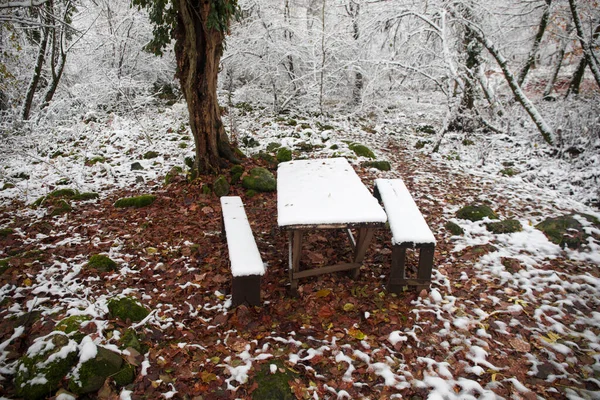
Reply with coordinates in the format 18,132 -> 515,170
15,332 -> 77,400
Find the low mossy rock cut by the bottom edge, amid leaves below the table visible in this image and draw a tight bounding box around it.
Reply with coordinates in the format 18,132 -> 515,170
252,360 -> 298,400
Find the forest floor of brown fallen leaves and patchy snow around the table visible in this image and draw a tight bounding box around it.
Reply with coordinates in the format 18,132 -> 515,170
0,101 -> 600,399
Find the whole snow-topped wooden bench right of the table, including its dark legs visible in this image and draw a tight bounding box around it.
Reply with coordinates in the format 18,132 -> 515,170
374,179 -> 435,293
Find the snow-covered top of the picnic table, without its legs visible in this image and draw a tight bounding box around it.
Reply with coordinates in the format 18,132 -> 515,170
277,158 -> 387,227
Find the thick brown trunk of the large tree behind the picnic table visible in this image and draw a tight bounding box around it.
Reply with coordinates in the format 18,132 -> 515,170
174,0 -> 238,174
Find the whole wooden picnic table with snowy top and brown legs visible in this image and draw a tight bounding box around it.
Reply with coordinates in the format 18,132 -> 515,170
277,158 -> 387,294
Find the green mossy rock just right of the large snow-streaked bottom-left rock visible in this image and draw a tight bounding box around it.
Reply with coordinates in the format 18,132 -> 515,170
69,346 -> 133,395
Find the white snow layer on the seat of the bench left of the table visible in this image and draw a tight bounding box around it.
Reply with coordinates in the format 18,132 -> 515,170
221,196 -> 265,277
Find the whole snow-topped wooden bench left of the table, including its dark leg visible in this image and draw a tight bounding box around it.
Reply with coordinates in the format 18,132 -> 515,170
221,196 -> 265,307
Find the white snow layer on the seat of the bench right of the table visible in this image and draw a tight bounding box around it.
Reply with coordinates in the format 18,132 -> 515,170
375,179 -> 436,245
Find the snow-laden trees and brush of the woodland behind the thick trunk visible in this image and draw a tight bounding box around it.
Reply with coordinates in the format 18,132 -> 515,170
0,0 -> 600,206
